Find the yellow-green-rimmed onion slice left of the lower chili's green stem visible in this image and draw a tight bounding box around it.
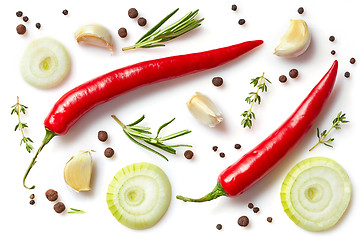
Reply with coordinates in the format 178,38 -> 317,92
106,162 -> 171,230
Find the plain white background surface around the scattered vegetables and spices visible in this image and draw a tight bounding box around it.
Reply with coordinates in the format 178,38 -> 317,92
0,0 -> 360,240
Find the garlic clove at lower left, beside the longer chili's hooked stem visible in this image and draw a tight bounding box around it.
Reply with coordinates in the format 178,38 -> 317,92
64,151 -> 93,191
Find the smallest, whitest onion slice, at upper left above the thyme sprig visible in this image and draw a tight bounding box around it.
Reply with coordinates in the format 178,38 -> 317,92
20,37 -> 70,88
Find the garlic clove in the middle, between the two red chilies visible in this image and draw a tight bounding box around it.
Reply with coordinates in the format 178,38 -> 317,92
186,92 -> 223,127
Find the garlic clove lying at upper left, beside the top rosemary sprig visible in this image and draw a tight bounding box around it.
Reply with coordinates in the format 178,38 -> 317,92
74,24 -> 113,52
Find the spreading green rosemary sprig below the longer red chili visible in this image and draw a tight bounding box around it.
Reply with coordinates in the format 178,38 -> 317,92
111,115 -> 191,161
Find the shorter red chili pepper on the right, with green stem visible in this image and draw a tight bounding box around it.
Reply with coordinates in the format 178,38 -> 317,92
177,61 -> 338,202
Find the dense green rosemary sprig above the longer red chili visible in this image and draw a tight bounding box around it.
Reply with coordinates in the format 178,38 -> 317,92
122,8 -> 204,51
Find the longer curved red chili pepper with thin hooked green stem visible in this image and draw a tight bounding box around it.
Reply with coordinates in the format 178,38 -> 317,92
23,40 -> 263,189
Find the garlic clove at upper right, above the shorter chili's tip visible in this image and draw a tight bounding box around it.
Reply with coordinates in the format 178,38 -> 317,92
274,20 -> 311,57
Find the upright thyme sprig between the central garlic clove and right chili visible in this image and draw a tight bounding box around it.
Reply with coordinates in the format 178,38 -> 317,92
241,73 -> 271,128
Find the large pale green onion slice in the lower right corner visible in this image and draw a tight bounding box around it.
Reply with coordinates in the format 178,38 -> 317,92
281,157 -> 351,231
